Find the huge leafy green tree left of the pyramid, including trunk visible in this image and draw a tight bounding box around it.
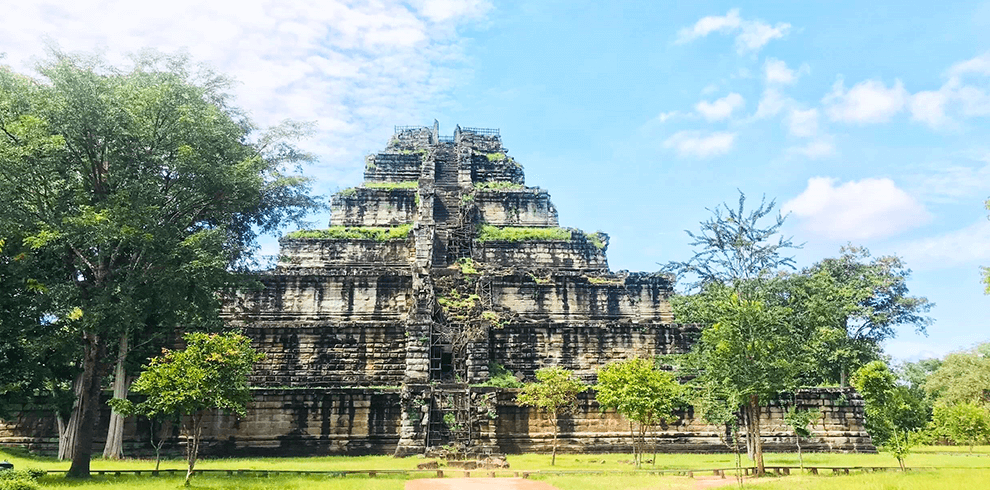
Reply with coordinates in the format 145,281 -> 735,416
0,51 -> 315,477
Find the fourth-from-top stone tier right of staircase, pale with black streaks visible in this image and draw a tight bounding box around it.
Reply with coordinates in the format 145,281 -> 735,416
492,274 -> 674,323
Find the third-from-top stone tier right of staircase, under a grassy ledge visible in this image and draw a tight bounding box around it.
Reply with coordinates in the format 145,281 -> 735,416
472,240 -> 608,272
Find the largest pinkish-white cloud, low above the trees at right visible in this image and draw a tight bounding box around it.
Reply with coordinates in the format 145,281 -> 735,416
781,177 -> 931,241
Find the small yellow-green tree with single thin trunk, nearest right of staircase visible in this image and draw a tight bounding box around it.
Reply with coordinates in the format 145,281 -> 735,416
516,367 -> 588,466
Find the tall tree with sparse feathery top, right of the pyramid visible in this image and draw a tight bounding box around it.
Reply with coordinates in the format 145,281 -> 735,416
664,192 -> 809,475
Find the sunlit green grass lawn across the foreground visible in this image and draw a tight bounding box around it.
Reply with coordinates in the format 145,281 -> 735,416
0,446 -> 990,490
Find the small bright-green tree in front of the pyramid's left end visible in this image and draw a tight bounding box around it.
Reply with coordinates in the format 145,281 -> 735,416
114,332 -> 264,486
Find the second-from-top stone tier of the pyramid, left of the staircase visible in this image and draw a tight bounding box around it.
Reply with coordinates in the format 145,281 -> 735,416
330,187 -> 416,226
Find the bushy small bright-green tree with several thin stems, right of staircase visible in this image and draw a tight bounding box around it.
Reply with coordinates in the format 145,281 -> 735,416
595,358 -> 682,467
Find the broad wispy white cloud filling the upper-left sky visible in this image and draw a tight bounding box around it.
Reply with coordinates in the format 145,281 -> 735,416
0,0 -> 491,192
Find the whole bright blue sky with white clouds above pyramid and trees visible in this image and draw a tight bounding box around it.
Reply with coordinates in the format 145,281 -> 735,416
0,0 -> 990,359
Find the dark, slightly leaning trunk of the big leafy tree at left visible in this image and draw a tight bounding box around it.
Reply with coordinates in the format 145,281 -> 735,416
65,333 -> 106,478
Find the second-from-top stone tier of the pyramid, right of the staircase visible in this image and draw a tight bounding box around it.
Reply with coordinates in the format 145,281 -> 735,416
474,188 -> 558,227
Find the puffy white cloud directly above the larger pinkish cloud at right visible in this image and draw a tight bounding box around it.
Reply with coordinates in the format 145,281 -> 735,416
822,78 -> 909,123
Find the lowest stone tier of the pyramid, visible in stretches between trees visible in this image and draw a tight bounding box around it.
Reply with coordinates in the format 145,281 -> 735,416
0,388 -> 876,457
